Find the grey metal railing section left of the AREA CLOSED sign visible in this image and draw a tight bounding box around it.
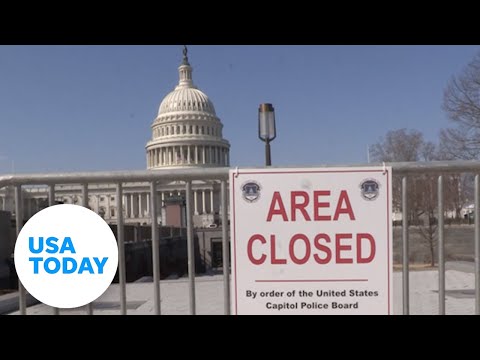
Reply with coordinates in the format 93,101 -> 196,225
0,168 -> 230,315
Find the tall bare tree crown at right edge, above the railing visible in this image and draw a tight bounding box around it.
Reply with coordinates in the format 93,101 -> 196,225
440,53 -> 480,160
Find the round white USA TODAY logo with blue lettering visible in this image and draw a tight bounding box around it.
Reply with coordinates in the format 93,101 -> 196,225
15,205 -> 118,309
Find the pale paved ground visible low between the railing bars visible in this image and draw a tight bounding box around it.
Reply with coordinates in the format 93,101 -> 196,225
6,266 -> 475,315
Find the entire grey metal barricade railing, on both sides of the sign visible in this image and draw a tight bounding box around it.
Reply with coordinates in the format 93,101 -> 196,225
0,161 -> 480,315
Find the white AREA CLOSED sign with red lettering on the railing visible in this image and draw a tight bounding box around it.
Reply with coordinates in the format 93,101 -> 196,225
230,167 -> 392,315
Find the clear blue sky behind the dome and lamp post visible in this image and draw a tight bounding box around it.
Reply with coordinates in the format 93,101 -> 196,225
0,45 -> 480,174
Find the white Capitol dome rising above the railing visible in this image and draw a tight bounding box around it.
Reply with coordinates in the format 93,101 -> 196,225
146,49 -> 230,170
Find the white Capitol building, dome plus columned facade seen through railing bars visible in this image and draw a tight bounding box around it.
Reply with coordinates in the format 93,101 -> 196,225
0,48 -> 230,228
